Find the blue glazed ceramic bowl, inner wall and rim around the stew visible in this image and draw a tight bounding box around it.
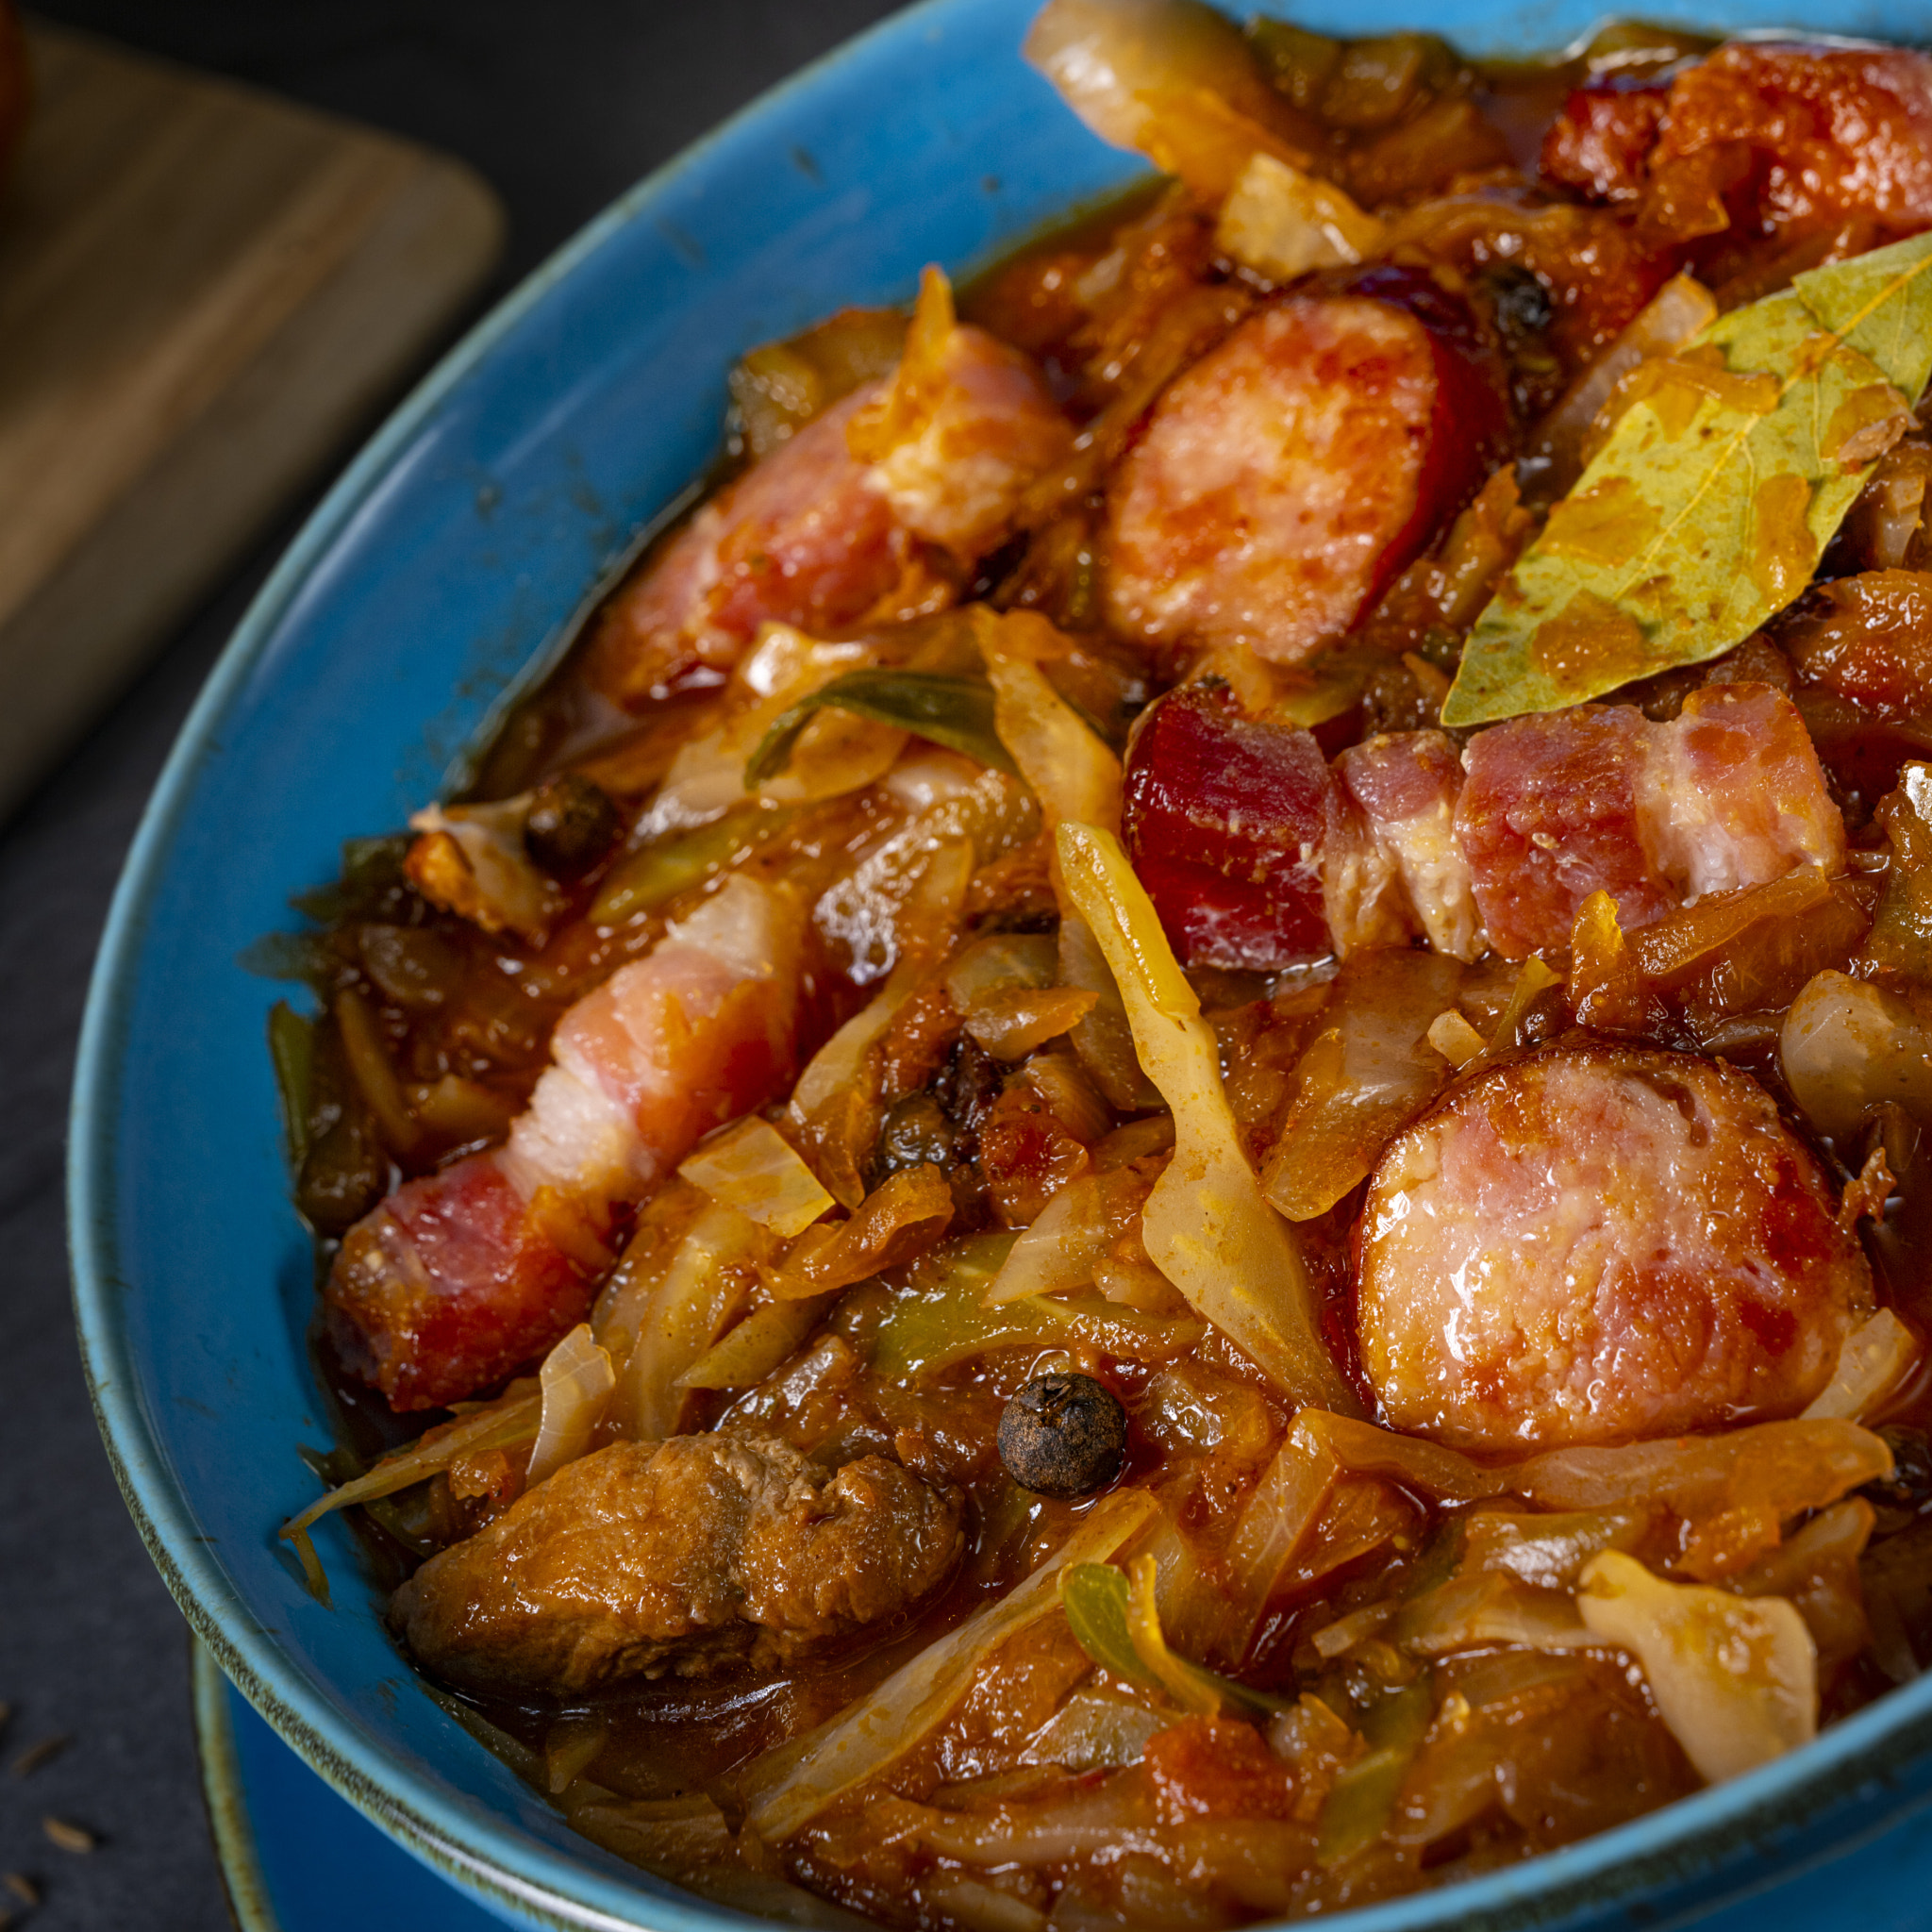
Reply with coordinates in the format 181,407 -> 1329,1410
72,0 -> 1932,1932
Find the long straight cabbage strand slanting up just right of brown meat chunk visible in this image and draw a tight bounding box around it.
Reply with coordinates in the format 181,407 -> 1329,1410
740,1490 -> 1156,1845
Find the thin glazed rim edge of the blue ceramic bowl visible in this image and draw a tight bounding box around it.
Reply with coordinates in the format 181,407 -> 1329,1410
66,0 -> 1932,1932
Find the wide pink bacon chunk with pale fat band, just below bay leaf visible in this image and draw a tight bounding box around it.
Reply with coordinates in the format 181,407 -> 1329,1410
1455,684 -> 1845,958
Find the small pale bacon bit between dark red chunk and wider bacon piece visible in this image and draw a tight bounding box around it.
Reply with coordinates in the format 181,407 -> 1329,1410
1322,730 -> 1486,960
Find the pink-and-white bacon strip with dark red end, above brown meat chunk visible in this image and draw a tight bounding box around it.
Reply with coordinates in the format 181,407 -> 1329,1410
326,877 -> 800,1410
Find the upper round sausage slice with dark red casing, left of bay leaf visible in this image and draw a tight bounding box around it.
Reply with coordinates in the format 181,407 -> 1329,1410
1105,267 -> 1505,665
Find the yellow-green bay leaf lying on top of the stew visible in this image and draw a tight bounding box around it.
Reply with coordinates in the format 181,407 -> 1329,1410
1441,234 -> 1932,726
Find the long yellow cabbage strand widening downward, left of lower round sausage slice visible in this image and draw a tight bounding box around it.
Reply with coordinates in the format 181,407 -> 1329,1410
1058,823 -> 1360,1414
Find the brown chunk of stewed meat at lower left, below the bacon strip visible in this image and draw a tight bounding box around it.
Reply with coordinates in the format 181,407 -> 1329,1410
391,1434 -> 960,1696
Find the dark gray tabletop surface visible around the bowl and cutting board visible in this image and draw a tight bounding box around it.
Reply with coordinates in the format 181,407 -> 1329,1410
0,0 -> 892,1932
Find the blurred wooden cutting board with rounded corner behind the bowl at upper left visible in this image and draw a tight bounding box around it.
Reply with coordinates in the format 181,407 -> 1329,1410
0,25 -> 502,813
